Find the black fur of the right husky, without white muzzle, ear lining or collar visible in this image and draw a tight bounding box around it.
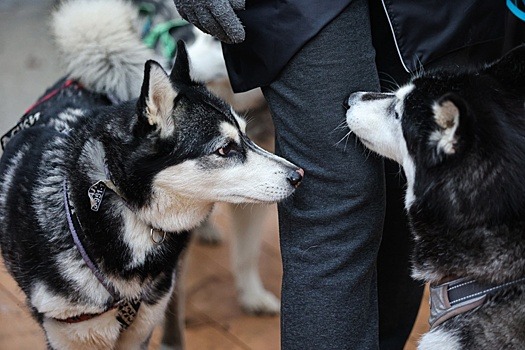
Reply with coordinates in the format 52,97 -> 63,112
402,46 -> 525,349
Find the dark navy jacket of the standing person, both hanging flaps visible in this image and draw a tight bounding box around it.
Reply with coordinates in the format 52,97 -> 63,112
223,0 -> 514,92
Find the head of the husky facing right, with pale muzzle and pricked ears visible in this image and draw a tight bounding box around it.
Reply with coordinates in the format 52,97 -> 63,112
105,42 -> 303,231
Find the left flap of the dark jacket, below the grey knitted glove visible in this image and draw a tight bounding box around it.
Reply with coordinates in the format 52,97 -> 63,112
223,0 -> 352,92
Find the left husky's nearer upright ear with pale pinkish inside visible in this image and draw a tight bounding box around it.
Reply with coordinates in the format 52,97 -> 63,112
137,60 -> 177,136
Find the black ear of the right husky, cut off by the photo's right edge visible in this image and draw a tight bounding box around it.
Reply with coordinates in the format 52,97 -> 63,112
484,44 -> 525,89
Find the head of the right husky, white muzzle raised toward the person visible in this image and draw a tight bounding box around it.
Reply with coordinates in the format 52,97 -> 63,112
347,46 -> 525,212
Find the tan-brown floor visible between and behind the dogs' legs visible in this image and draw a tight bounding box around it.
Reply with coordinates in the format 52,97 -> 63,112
0,207 -> 428,350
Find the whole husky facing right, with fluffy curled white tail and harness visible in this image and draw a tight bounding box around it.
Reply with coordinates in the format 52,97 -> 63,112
0,0 -> 303,350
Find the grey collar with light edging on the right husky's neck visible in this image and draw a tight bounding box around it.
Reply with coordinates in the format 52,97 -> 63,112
429,277 -> 525,329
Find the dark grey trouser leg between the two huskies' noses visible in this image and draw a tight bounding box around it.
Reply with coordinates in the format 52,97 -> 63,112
263,0 -> 385,350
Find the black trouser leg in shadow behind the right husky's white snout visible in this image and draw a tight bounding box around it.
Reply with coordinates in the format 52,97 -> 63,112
369,0 -> 424,350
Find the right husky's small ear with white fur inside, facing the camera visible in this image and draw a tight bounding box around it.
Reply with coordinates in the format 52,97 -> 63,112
430,93 -> 467,158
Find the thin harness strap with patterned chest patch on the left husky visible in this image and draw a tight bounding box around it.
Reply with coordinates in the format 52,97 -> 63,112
58,180 -> 142,330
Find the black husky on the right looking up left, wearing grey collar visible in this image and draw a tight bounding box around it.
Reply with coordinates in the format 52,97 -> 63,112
346,46 -> 525,350
